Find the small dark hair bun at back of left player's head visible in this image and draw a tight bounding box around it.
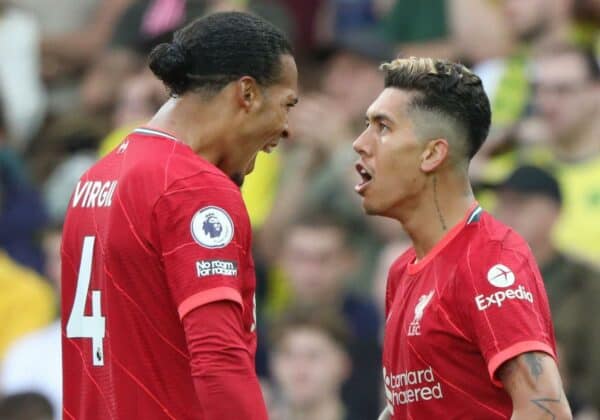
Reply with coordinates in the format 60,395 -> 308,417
148,42 -> 189,95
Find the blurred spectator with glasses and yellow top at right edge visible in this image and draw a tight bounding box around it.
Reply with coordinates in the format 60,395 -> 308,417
517,47 -> 600,264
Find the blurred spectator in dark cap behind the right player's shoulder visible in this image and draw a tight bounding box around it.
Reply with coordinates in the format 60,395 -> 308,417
496,166 -> 600,415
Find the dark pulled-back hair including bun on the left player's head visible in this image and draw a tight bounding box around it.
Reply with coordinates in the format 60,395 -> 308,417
149,12 -> 292,96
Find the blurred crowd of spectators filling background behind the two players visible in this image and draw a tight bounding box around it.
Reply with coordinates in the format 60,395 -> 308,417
0,0 -> 600,420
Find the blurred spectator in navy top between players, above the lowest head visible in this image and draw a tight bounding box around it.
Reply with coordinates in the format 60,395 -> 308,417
263,215 -> 380,418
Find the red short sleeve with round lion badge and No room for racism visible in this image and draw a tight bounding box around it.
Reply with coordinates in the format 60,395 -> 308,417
153,174 -> 252,318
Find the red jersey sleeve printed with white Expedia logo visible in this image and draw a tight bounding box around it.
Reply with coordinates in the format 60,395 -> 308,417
455,235 -> 556,387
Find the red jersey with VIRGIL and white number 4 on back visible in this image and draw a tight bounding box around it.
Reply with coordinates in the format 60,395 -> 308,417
62,129 -> 256,420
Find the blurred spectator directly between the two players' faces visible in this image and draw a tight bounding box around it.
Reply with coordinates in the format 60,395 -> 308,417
257,36 -> 400,282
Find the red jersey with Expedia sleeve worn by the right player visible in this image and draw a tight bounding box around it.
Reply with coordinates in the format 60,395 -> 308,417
383,205 -> 556,420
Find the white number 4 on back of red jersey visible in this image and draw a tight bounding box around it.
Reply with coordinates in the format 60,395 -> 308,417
67,236 -> 106,366
